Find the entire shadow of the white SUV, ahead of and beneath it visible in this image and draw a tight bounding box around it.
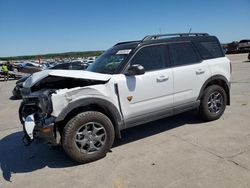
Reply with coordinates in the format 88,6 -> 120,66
0,112 -> 201,181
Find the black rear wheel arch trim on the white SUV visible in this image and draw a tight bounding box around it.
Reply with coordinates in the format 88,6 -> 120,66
198,75 -> 230,105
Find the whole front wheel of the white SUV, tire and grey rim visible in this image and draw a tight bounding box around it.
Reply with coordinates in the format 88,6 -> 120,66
62,111 -> 115,163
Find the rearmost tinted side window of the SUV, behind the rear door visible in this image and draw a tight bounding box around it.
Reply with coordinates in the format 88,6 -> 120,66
195,41 -> 224,59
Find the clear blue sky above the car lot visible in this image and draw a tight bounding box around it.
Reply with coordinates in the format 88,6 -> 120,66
0,0 -> 250,57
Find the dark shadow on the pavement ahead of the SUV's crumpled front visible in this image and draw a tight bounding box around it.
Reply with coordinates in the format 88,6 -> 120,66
0,131 -> 77,181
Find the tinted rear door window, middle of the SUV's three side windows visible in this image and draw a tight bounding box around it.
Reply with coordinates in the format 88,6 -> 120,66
169,43 -> 199,66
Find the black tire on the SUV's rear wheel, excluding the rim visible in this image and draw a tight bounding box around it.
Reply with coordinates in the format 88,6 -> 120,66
199,85 -> 227,121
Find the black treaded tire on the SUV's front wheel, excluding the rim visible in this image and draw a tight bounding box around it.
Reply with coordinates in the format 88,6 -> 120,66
62,111 -> 115,163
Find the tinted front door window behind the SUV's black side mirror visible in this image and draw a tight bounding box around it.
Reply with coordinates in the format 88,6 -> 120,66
130,45 -> 166,71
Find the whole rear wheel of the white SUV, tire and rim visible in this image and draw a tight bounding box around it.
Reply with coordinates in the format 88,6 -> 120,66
199,85 -> 227,121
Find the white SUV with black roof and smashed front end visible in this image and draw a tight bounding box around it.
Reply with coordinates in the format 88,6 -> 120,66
19,33 -> 231,163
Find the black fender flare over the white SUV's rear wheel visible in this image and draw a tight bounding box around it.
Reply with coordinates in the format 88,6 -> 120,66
197,75 -> 231,105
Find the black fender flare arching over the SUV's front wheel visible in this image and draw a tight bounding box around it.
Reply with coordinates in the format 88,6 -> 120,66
55,97 -> 124,138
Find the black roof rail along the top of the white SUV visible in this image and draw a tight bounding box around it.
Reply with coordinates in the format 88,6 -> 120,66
142,33 -> 209,42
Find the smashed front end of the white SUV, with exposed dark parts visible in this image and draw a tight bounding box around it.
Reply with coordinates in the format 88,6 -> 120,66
19,92 -> 60,145
